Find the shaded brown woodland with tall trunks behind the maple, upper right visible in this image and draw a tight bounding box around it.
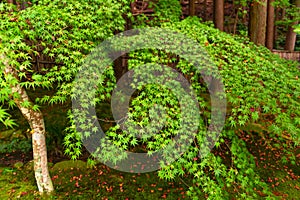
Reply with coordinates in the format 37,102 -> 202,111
133,0 -> 300,60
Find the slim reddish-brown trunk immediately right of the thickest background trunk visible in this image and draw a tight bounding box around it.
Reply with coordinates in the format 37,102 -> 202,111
266,0 -> 275,50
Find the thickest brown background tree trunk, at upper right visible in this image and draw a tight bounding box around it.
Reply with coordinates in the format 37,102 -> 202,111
249,0 -> 267,45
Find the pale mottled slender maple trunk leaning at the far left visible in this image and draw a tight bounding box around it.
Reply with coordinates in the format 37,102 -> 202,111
0,55 -> 54,193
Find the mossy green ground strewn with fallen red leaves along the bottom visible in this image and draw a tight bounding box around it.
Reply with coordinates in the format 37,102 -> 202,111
0,138 -> 300,200
